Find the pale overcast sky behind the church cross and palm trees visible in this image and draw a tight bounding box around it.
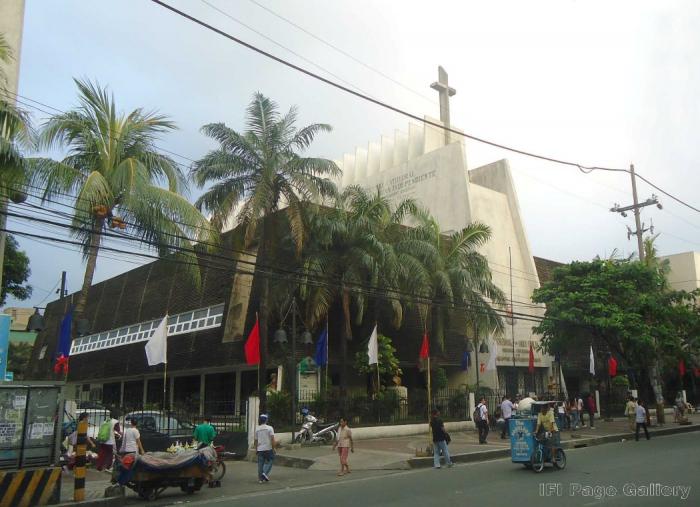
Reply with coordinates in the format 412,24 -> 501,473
8,0 -> 700,306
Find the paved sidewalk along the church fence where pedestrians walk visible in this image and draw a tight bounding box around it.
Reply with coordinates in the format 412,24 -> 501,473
276,414 -> 700,470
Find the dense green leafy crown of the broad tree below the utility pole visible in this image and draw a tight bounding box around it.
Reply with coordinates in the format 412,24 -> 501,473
532,260 -> 700,376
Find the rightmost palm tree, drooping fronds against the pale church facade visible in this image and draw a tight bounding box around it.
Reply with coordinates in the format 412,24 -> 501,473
411,210 -> 505,347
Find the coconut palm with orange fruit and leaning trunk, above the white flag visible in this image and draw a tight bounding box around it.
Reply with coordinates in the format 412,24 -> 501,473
32,80 -> 217,317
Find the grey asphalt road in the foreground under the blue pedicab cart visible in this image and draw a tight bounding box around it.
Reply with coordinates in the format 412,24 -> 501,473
145,432 -> 700,507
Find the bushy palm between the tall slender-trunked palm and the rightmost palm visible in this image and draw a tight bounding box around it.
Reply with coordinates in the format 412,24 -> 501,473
301,186 -> 429,389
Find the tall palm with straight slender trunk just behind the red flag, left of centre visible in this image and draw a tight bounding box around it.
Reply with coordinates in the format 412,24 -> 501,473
191,92 -> 340,409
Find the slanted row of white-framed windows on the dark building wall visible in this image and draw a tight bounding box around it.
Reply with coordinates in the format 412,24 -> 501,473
70,304 -> 224,355
